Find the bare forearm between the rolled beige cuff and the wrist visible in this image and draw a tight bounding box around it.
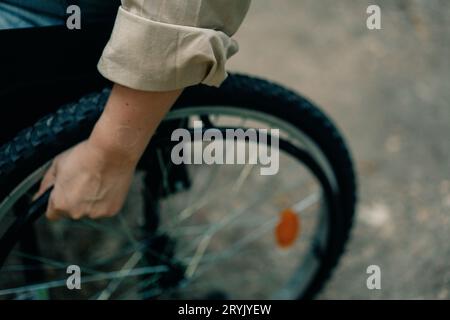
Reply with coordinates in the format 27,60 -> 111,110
89,84 -> 182,164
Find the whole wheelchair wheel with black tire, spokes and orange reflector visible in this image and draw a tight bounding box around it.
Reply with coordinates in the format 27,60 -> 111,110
0,75 -> 356,299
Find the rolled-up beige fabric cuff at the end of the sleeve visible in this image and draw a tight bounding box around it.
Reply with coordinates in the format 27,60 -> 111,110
98,7 -> 238,91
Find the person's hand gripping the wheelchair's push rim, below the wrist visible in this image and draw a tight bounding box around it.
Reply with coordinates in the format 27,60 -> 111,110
35,140 -> 135,220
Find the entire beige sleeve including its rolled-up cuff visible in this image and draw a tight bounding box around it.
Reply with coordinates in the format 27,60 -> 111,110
98,0 -> 251,91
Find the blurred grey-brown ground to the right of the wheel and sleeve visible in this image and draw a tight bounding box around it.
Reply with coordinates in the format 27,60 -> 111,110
230,0 -> 450,299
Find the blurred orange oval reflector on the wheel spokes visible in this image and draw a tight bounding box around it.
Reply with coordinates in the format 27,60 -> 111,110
275,209 -> 301,248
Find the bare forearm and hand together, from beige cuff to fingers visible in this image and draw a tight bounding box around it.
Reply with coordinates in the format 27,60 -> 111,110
35,84 -> 182,220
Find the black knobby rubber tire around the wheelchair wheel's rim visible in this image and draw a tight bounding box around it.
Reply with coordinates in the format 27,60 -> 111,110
0,74 -> 356,299
